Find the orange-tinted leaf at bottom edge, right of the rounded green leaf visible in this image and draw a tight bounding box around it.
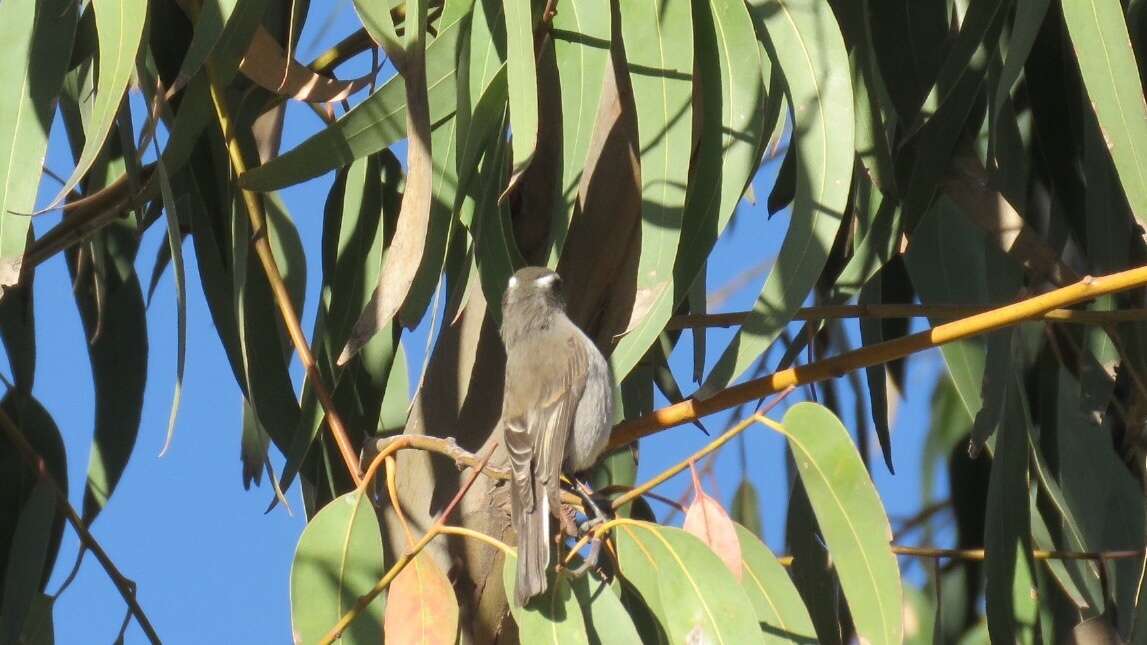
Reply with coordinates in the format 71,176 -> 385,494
383,551 -> 458,645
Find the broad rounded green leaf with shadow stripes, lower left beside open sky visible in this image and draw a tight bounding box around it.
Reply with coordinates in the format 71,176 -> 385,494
290,491 -> 387,643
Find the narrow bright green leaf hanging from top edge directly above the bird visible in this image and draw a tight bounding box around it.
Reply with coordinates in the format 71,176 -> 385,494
502,0 -> 538,186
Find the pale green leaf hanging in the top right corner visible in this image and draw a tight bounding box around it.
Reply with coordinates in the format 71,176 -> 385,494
1062,0 -> 1147,223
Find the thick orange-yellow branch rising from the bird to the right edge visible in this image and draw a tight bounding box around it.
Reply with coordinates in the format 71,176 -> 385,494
607,266 -> 1147,450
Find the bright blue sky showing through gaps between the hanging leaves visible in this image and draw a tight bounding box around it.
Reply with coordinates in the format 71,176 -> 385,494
20,1 -> 946,643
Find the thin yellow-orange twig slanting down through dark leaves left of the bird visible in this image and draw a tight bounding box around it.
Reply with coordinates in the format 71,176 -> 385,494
208,67 -> 362,485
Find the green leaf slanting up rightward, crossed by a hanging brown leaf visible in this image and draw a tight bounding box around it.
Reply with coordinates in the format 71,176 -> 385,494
239,11 -> 462,192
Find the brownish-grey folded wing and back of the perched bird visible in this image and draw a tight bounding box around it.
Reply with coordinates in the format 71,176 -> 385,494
504,328 -> 588,513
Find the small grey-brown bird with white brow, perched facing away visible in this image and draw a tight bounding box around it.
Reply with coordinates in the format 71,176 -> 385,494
501,266 -> 614,606
